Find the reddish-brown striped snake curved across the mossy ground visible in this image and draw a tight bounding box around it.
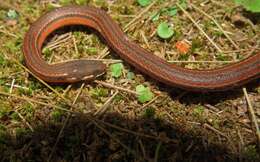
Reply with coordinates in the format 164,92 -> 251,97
23,6 -> 260,91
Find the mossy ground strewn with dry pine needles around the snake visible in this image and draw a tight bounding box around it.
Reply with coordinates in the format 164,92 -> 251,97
0,0 -> 260,162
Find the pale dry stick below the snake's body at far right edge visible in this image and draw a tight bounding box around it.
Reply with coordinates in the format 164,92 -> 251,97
243,88 -> 260,146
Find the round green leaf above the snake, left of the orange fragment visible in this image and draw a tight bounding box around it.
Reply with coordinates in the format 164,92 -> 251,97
157,22 -> 174,39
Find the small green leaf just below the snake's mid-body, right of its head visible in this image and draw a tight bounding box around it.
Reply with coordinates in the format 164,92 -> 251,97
135,85 -> 154,103
